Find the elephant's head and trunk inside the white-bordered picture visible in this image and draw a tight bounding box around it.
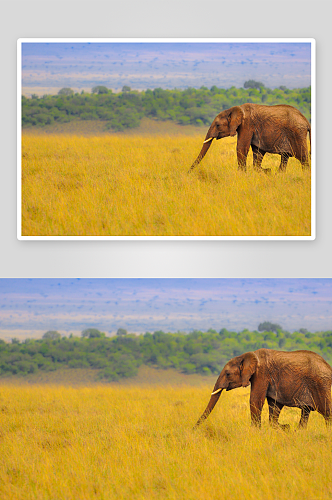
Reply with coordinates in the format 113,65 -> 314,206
189,106 -> 244,172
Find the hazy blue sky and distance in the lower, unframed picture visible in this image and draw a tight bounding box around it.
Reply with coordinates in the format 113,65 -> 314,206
0,278 -> 332,340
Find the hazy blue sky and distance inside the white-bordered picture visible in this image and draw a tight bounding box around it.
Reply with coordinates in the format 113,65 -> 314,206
22,42 -> 311,95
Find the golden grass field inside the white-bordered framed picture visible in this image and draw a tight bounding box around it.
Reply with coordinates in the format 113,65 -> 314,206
22,134 -> 311,236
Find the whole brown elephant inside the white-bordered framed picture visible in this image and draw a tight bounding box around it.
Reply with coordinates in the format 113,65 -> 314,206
188,103 -> 311,173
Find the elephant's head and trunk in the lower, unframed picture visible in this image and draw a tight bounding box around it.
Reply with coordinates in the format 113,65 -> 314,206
195,352 -> 259,427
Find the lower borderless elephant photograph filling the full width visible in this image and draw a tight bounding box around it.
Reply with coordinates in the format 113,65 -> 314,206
0,278 -> 332,500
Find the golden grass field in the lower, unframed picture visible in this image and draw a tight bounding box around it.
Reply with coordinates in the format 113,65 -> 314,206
0,385 -> 332,500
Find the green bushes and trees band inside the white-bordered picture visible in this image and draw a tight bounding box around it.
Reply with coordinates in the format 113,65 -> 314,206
22,86 -> 311,131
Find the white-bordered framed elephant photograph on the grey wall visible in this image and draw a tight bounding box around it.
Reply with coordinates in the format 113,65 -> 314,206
17,38 -> 316,240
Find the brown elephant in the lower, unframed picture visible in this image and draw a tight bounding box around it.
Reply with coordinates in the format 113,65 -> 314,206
195,349 -> 332,428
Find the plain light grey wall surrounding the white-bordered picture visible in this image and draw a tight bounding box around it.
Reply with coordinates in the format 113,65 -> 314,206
0,0 -> 332,277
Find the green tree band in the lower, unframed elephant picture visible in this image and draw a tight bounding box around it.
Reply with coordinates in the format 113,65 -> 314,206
0,323 -> 332,381
